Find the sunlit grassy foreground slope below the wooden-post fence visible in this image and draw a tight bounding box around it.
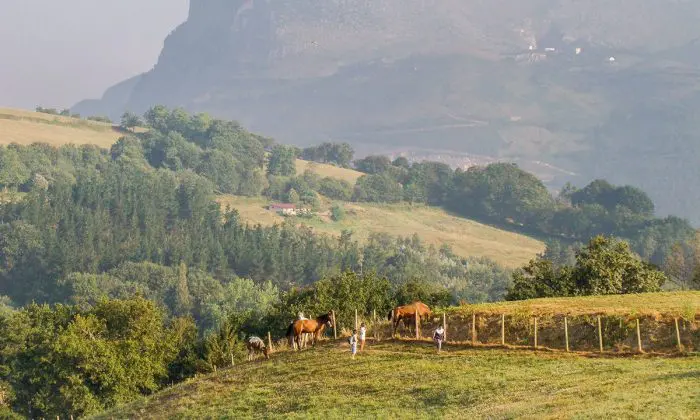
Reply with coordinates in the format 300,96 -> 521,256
97,341 -> 700,419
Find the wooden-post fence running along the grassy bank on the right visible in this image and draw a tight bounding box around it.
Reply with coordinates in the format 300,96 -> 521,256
360,311 -> 700,354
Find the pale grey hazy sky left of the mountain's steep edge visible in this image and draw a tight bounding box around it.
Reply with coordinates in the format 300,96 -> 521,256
0,0 -> 188,109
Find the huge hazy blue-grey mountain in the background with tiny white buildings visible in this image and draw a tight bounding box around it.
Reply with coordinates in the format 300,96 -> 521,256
73,0 -> 700,223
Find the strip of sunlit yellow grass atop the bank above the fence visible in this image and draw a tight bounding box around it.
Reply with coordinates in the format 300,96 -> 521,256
449,291 -> 700,319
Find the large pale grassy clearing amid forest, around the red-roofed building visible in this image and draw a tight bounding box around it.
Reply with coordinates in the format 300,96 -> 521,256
218,196 -> 545,268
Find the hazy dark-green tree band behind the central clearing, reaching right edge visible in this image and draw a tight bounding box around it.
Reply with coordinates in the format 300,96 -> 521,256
352,156 -> 695,265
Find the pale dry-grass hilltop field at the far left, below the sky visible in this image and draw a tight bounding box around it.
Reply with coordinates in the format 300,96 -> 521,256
0,108 -> 123,148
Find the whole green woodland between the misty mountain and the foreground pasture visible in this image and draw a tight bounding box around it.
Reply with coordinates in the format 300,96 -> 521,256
0,107 -> 700,417
